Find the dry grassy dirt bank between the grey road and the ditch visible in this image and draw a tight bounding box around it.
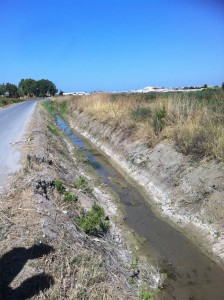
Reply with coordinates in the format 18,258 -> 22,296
0,104 -> 156,299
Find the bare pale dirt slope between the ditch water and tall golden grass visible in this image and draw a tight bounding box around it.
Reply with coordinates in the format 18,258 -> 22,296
62,102 -> 224,263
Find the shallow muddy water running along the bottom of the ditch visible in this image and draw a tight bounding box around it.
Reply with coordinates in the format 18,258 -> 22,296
56,116 -> 224,300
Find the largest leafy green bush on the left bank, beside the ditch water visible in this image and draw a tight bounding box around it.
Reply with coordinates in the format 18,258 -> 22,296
76,203 -> 109,236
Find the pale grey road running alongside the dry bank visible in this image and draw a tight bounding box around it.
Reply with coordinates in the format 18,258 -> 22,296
0,100 -> 37,194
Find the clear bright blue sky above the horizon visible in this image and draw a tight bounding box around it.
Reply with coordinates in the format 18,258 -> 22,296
0,0 -> 224,91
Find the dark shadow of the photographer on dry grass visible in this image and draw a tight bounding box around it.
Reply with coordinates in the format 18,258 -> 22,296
0,244 -> 54,300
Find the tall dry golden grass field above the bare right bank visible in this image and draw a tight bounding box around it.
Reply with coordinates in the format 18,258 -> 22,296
57,88 -> 224,161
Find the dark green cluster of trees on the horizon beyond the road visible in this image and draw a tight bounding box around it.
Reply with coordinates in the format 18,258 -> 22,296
0,78 -> 58,98
